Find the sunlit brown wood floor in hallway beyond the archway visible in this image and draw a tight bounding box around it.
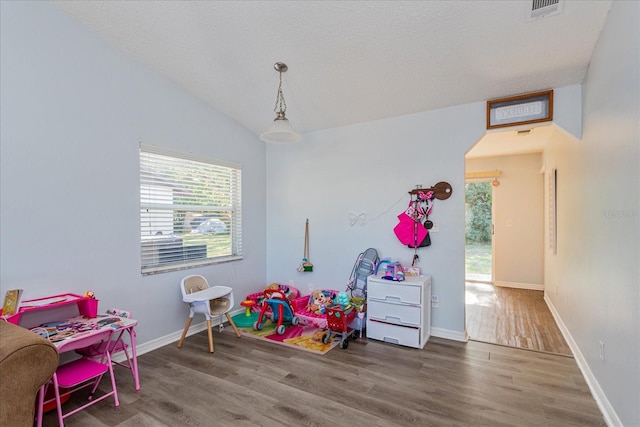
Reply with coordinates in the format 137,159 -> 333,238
466,282 -> 573,356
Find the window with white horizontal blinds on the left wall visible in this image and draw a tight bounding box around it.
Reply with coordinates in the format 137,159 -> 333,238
140,144 -> 242,274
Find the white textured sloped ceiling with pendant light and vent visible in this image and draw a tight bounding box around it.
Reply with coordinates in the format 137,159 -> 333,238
53,0 -> 611,140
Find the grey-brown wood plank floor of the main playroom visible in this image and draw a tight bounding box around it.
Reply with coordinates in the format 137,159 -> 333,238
45,331 -> 606,427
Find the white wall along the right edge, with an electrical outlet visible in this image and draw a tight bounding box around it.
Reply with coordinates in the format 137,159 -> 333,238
544,2 -> 640,426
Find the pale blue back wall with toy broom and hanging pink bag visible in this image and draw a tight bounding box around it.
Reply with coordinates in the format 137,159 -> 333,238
267,103 -> 485,339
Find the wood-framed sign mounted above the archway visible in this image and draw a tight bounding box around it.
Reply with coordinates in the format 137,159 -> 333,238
487,90 -> 553,129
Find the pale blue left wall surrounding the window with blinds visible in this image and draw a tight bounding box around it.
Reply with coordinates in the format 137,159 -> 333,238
0,1 -> 266,343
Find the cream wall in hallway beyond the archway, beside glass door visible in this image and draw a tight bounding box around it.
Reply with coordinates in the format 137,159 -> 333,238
466,152 -> 545,290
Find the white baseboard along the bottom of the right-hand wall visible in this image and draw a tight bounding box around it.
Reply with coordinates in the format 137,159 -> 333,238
544,294 -> 623,427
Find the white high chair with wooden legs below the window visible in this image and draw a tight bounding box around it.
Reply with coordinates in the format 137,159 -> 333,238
178,274 -> 240,353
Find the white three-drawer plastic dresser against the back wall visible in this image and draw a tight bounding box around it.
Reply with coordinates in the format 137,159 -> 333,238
367,276 -> 431,348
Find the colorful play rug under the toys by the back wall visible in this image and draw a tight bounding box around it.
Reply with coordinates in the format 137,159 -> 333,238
230,319 -> 340,355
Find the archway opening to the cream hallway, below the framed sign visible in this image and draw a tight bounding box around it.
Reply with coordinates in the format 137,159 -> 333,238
465,126 -> 571,355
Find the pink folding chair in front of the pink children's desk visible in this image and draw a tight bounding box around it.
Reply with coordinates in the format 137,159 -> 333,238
37,328 -> 120,427
